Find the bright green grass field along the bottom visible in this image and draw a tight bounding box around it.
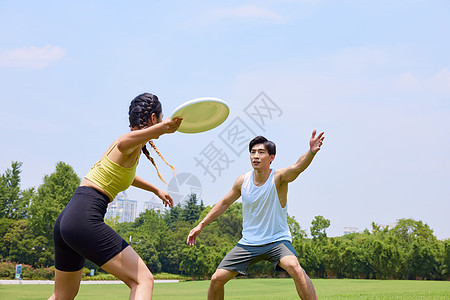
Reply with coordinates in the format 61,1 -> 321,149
0,279 -> 450,300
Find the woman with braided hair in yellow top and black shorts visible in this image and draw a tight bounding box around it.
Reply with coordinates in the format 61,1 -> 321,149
49,93 -> 182,299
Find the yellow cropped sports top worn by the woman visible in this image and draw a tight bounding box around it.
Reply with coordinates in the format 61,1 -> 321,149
85,142 -> 139,199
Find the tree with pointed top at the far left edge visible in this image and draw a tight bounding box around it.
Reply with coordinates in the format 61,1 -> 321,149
0,161 -> 34,220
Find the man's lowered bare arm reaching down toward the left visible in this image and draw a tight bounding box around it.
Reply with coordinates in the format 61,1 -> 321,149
186,175 -> 244,246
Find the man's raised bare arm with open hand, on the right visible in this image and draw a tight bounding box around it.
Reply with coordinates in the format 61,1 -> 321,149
279,129 -> 325,183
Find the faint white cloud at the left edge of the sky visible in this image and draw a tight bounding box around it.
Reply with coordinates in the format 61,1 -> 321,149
0,45 -> 65,69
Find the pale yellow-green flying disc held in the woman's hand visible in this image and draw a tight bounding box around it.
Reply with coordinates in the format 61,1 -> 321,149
171,97 -> 230,133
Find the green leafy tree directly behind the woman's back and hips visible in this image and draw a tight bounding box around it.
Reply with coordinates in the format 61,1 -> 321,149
29,162 -> 80,241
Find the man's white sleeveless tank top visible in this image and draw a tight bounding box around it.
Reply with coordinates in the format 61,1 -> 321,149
239,170 -> 292,246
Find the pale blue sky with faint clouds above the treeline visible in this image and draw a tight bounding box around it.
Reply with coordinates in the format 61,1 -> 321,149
0,0 -> 450,239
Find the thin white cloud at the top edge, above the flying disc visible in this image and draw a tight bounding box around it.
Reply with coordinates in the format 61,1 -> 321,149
209,5 -> 284,21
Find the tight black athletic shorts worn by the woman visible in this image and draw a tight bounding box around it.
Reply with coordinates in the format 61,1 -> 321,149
53,186 -> 128,272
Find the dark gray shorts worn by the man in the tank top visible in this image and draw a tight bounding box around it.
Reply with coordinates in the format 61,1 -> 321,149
217,241 -> 297,275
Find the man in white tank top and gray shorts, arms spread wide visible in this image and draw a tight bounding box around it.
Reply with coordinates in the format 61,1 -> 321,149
187,130 -> 325,300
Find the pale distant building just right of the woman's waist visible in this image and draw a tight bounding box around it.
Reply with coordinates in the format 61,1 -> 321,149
105,191 -> 137,223
